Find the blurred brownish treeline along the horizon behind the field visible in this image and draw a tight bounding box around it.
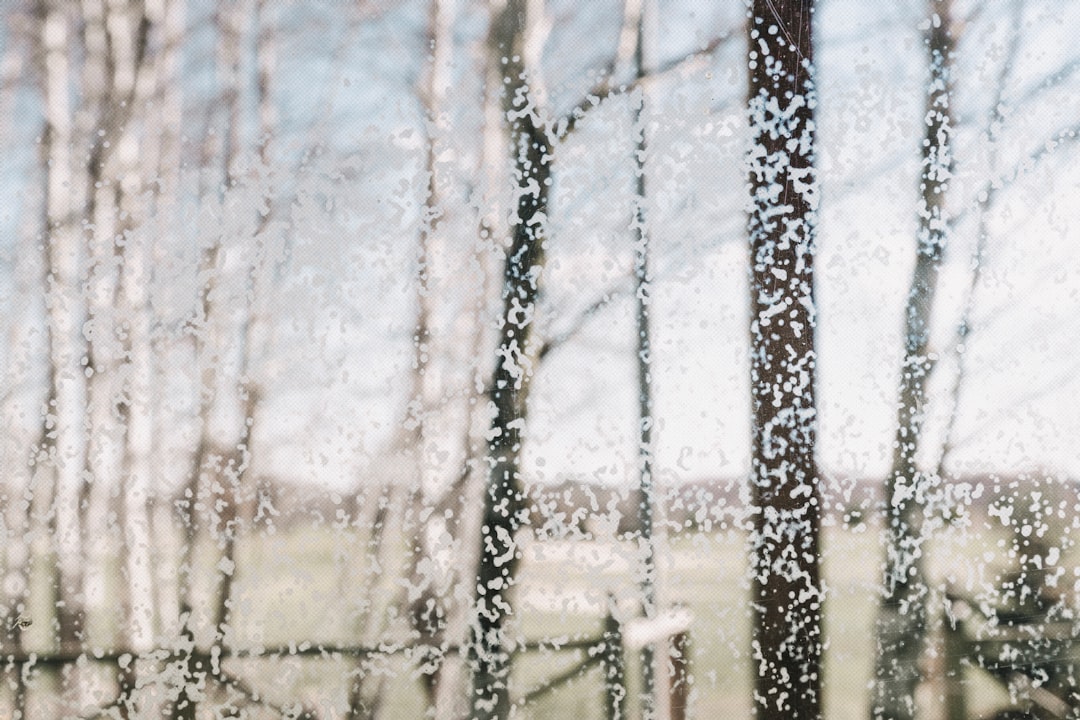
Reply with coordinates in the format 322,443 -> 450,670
214,471 -> 1080,540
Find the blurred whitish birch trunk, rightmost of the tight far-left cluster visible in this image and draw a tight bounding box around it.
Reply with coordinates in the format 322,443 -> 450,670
113,0 -> 184,669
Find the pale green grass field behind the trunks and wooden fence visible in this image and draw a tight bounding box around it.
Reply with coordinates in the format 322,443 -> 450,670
6,507 -> 1062,720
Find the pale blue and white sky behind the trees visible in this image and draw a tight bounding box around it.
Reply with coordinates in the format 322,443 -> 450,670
0,0 -> 1080,496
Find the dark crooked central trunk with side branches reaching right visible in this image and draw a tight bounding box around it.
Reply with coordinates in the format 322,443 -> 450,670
470,0 -> 552,720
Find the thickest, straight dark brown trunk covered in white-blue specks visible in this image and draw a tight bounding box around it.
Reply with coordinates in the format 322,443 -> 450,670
747,0 -> 824,720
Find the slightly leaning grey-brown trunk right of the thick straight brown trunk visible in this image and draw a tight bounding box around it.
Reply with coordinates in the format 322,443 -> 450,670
870,0 -> 953,720
